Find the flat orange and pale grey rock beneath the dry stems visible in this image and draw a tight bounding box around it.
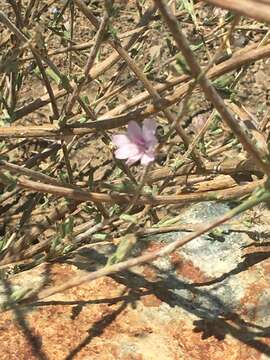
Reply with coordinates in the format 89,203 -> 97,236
0,202 -> 270,360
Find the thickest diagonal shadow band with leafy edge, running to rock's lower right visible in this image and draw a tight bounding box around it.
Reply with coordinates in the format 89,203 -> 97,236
112,271 -> 270,356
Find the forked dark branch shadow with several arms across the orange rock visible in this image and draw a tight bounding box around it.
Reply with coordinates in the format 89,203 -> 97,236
31,243 -> 270,360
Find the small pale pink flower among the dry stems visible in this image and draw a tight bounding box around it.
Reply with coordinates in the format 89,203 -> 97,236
112,119 -> 158,165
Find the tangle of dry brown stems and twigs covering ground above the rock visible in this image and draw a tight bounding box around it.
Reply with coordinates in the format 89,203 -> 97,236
0,0 -> 270,358
